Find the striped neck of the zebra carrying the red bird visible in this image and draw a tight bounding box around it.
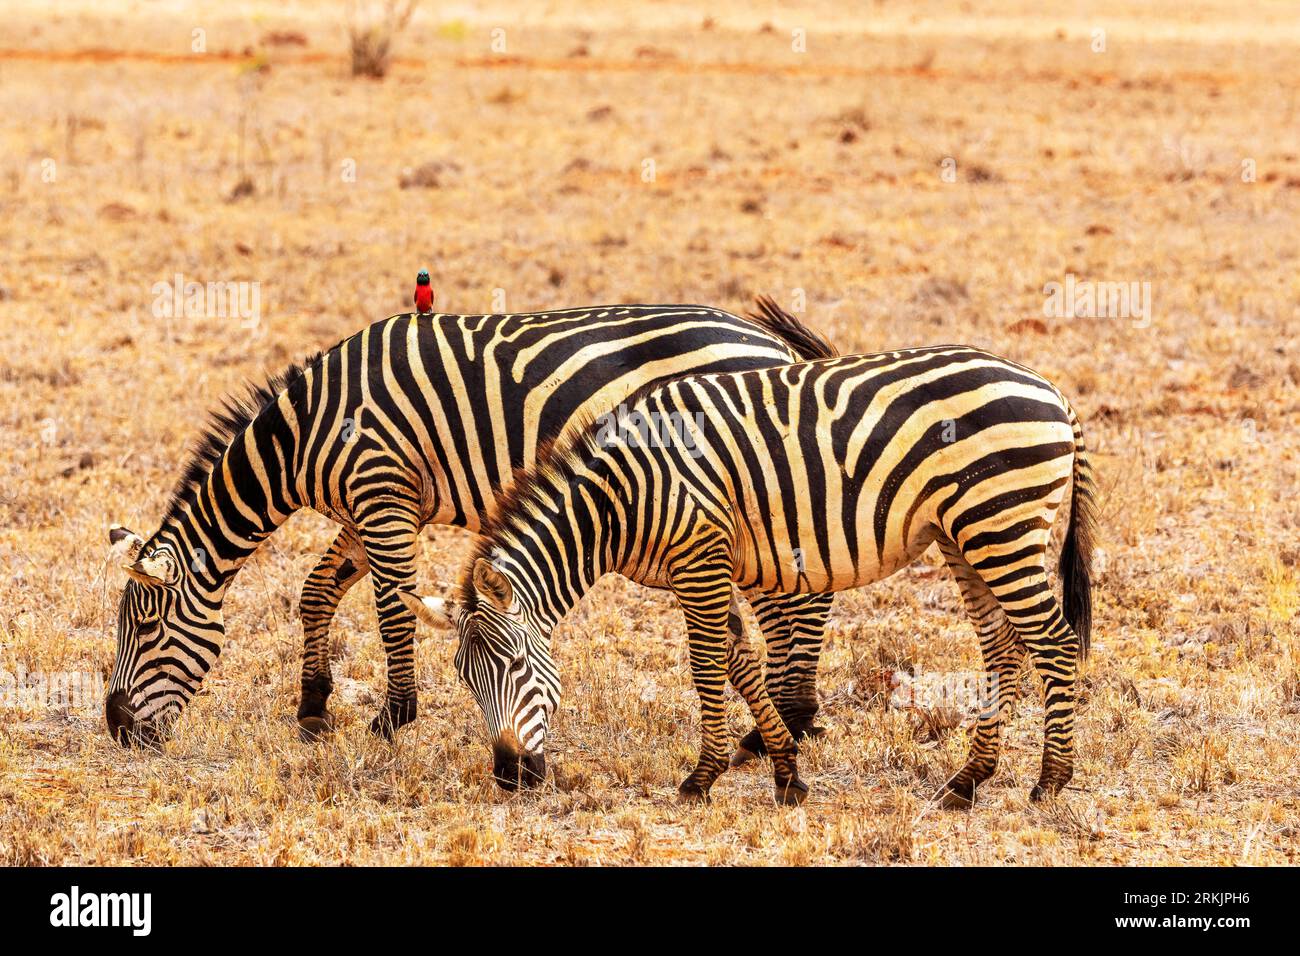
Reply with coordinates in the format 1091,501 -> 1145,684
157,395 -> 302,601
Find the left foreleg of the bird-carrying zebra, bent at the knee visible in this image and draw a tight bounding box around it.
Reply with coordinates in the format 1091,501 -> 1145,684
298,527 -> 368,741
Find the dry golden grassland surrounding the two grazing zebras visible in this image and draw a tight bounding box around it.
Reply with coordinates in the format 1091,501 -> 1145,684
0,0 -> 1300,865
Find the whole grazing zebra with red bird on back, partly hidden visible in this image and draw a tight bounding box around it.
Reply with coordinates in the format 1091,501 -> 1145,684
105,299 -> 835,743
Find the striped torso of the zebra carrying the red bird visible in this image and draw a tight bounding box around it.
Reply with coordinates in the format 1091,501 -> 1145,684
290,306 -> 796,528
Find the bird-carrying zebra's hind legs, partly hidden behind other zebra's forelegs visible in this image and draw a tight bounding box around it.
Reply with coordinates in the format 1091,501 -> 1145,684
731,592 -> 835,767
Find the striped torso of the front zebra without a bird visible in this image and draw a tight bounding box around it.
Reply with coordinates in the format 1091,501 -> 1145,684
618,346 -> 1075,593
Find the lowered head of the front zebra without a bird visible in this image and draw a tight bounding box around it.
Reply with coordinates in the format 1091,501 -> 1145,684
402,558 -> 560,791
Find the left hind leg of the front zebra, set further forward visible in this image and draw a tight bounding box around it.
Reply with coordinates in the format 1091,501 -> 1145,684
936,537 -> 1024,809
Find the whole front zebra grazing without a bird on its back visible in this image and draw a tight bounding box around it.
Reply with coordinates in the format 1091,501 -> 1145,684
403,346 -> 1095,806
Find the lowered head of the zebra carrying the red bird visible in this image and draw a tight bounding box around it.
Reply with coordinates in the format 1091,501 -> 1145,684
104,525 -> 225,747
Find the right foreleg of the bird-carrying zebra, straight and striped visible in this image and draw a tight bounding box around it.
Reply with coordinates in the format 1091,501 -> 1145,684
354,488 -> 420,740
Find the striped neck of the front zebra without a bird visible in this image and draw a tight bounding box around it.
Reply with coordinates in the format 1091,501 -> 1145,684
484,459 -> 619,630
